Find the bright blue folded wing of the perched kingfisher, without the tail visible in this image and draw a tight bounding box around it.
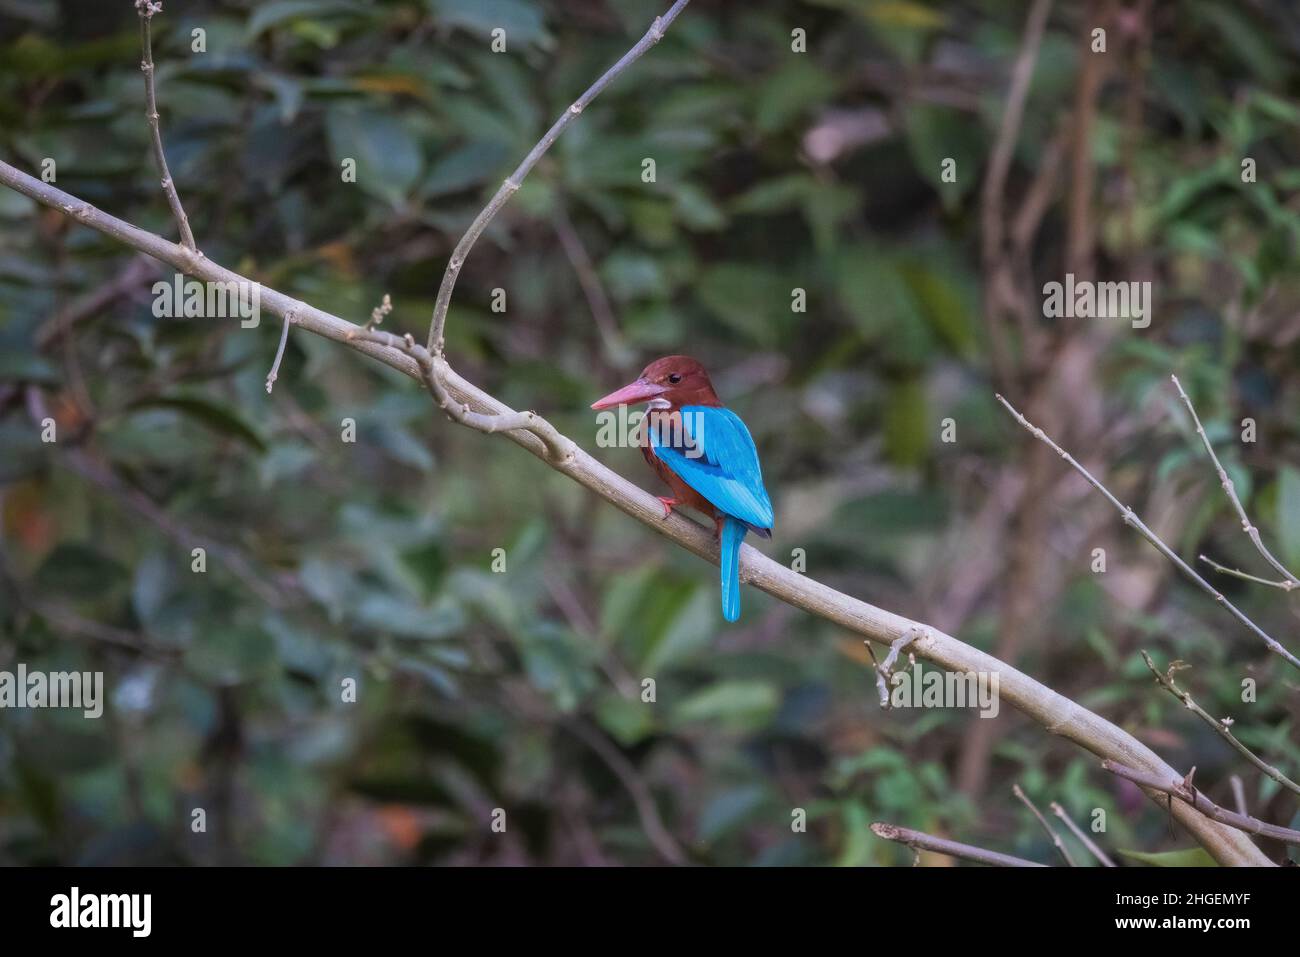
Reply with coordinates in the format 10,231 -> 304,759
649,406 -> 772,529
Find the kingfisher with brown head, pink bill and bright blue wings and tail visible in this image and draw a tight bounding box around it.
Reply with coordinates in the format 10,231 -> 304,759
592,355 -> 772,622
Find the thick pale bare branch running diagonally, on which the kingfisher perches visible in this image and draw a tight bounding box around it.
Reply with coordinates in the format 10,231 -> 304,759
0,161 -> 1273,866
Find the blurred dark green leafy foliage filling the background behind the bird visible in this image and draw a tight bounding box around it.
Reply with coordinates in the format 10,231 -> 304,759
0,0 -> 1300,866
